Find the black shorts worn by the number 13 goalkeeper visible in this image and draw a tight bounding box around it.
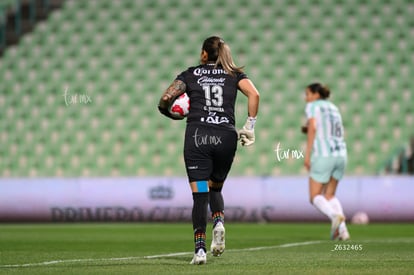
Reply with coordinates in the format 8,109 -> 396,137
184,123 -> 237,182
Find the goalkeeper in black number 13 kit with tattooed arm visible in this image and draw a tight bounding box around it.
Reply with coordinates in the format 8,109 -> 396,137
158,36 -> 259,264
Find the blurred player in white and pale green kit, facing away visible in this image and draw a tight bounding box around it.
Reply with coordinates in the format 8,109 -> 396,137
303,83 -> 350,240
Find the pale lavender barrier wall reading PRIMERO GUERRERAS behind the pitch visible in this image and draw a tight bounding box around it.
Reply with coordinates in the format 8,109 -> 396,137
0,176 -> 414,222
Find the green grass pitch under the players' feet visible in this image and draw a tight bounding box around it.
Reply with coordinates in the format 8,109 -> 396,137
0,223 -> 414,275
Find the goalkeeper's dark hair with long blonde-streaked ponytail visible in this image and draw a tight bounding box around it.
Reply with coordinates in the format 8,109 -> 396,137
202,36 -> 243,75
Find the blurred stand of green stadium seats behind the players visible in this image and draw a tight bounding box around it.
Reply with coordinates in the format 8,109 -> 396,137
0,0 -> 414,223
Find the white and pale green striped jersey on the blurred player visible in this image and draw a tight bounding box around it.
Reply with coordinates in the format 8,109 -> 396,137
305,100 -> 347,157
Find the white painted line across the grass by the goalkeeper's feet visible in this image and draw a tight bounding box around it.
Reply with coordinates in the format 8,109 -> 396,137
0,241 -> 322,268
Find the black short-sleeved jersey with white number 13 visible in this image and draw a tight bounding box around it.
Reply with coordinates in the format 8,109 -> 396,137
176,64 -> 247,129
